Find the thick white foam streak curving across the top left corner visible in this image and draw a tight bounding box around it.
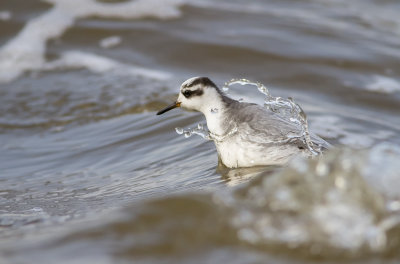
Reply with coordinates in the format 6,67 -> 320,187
0,0 -> 181,83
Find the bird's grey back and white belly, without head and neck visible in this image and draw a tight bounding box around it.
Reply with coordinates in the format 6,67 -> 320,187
217,101 -> 329,166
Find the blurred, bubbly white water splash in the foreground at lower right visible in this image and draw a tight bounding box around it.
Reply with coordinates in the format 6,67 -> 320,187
227,144 -> 400,256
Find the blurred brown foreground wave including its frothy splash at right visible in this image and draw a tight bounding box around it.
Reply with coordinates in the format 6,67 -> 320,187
3,144 -> 400,263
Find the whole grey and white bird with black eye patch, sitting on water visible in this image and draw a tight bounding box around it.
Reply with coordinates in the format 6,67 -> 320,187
157,77 -> 330,168
